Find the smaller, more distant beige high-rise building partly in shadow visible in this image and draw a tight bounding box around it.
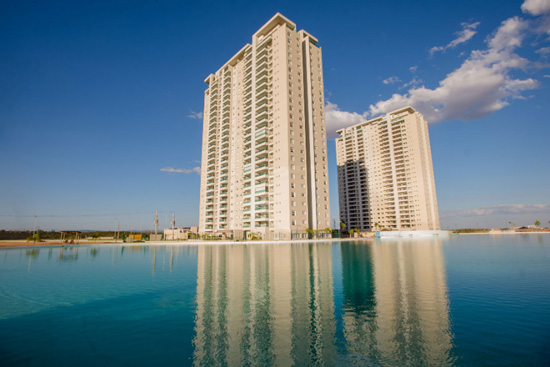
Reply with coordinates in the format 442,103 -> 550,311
336,107 -> 439,231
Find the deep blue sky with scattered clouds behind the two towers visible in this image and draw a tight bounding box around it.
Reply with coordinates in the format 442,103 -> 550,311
0,0 -> 550,230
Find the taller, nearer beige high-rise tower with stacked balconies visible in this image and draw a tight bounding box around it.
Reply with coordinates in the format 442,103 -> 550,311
199,14 -> 330,239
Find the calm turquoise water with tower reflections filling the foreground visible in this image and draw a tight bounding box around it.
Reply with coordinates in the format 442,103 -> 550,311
0,234 -> 550,366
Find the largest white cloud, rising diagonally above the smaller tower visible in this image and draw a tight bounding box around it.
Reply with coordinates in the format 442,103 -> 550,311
369,17 -> 538,122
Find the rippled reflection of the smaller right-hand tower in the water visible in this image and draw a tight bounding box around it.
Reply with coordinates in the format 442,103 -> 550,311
342,240 -> 452,365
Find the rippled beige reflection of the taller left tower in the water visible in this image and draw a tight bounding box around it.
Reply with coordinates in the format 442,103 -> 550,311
194,244 -> 336,366
